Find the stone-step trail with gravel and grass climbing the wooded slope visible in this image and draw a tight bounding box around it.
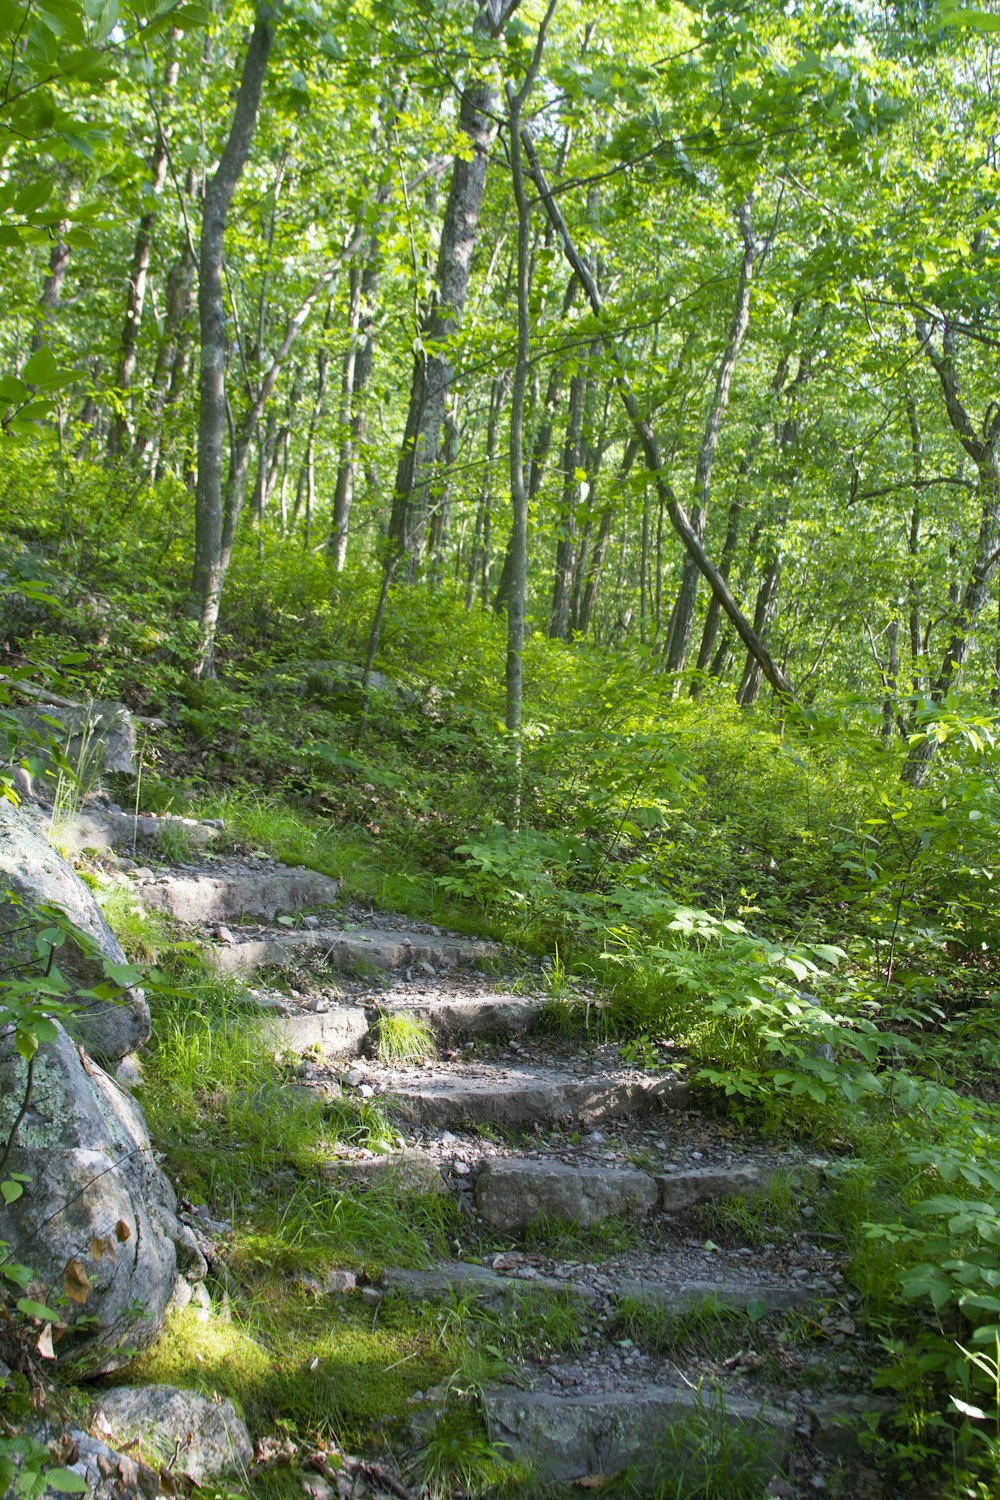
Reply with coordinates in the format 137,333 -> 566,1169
83,810 -> 877,1496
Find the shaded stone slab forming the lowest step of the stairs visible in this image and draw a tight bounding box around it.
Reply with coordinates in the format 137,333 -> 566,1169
483,1386 -> 795,1484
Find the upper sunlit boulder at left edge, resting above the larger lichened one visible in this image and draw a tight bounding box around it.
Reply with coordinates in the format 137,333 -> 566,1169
0,801 -> 150,1064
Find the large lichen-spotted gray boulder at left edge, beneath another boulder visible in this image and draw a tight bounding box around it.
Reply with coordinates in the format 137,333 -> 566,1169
0,1028 -> 179,1374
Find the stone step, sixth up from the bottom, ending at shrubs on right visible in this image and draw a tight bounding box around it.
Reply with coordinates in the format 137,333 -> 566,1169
208,927 -> 496,974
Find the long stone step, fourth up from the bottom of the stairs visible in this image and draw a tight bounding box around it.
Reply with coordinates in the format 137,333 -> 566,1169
358,1064 -> 690,1130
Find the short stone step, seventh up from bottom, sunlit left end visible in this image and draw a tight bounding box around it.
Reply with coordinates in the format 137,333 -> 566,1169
139,866 -> 340,924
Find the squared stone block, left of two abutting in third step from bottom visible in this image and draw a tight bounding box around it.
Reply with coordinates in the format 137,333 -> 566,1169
475,1157 -> 658,1230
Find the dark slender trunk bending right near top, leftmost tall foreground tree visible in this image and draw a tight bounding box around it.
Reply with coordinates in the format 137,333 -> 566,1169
189,6 -> 274,678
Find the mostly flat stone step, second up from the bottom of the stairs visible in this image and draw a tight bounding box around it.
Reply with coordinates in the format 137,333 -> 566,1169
379,1257 -> 817,1314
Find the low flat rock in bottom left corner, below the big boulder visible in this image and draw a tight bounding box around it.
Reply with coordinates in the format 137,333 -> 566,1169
94,1386 -> 253,1485
